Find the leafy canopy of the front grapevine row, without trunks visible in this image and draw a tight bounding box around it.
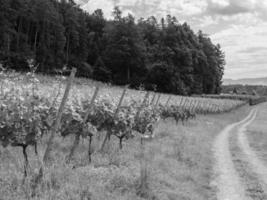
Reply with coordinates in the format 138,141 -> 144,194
0,73 -> 246,152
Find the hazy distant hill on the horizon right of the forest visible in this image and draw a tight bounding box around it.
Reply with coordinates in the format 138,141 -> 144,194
223,77 -> 267,85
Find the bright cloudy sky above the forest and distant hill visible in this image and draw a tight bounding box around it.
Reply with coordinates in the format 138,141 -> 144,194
77,0 -> 267,79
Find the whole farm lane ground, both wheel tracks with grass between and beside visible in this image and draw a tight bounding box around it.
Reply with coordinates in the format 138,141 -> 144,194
213,103 -> 267,200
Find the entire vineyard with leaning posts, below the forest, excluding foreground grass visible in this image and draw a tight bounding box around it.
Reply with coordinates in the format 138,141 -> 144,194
0,69 -> 246,196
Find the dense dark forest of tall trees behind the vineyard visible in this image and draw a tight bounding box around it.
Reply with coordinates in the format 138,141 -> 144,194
0,0 -> 225,95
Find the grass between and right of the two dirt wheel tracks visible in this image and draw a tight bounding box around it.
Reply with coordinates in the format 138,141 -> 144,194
227,103 -> 267,199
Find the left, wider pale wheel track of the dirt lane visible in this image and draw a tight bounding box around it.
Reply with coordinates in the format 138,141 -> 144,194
213,110 -> 255,200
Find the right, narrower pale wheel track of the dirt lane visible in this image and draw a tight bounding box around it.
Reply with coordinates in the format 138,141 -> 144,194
238,108 -> 267,188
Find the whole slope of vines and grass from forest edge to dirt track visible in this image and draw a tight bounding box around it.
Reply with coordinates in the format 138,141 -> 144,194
0,70 -> 249,200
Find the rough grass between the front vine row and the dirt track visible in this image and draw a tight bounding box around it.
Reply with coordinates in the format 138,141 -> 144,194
0,107 -> 249,200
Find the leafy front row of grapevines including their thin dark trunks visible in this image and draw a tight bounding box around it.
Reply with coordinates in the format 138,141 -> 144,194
0,70 -> 248,176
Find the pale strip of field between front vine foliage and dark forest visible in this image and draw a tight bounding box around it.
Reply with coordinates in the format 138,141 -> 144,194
0,74 -> 246,111
